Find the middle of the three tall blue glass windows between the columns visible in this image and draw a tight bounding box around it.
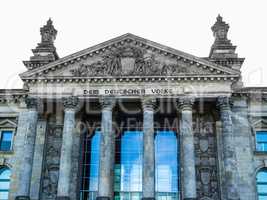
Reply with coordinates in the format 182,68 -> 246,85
114,131 -> 143,200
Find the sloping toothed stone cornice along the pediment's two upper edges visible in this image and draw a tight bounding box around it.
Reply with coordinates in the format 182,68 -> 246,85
20,34 -> 240,80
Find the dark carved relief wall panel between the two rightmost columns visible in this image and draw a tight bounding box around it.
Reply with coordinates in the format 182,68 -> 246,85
194,115 -> 220,200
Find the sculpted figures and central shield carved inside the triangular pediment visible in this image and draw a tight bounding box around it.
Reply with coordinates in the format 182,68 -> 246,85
70,46 -> 205,77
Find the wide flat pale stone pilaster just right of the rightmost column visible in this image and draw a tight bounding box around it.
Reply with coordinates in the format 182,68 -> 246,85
232,95 -> 257,200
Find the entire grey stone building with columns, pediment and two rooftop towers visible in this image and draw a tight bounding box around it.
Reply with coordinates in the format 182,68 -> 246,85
0,15 -> 267,200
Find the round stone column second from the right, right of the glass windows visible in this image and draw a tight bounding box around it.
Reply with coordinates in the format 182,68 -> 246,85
178,97 -> 197,200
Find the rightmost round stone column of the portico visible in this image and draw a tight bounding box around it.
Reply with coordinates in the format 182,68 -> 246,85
217,97 -> 240,200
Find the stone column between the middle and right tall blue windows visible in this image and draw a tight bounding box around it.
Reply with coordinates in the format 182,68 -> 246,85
142,99 -> 156,200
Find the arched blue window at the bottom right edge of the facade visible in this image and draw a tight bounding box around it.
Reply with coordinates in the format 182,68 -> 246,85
257,168 -> 267,200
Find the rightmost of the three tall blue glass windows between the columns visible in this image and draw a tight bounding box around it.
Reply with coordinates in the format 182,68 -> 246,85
155,131 -> 179,200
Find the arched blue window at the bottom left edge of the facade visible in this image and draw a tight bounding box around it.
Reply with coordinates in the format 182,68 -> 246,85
0,167 -> 11,200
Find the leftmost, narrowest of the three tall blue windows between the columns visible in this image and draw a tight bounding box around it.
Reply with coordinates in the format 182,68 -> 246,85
80,131 -> 101,200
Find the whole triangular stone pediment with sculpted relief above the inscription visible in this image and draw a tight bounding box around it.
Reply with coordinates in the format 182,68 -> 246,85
20,34 -> 240,80
